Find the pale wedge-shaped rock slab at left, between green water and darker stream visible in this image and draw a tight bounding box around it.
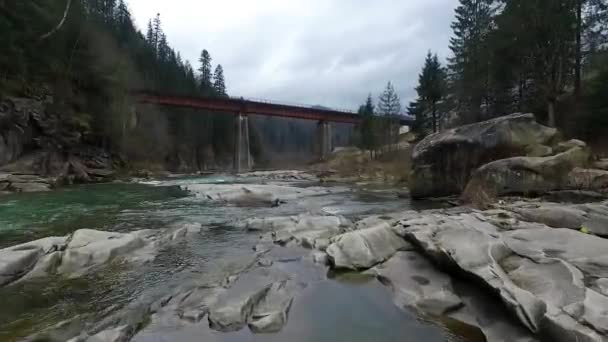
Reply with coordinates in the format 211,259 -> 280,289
57,229 -> 144,277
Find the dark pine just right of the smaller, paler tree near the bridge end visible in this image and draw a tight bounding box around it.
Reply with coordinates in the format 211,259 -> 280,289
415,51 -> 447,132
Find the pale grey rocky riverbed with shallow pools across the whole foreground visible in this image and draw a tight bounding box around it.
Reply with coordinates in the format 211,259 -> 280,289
0,173 -> 608,341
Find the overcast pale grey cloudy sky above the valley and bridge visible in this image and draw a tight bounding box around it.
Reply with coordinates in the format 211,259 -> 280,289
128,0 -> 458,108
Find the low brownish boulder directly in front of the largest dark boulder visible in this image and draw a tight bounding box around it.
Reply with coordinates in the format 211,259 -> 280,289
463,147 -> 590,199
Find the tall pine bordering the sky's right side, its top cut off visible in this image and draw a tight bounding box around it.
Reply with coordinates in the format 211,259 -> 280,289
448,0 -> 496,121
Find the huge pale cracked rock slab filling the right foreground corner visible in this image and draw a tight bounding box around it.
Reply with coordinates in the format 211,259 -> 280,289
399,212 -> 608,342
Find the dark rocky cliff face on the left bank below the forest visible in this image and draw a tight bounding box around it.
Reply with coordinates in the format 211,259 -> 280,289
0,97 -> 116,192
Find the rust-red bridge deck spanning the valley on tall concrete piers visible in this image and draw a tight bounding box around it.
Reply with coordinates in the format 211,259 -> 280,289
135,92 -> 413,125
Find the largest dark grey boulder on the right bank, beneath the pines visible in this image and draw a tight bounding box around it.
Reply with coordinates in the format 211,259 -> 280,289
411,114 -> 557,198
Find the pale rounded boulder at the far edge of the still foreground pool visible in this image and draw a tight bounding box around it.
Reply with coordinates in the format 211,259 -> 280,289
327,227 -> 411,270
